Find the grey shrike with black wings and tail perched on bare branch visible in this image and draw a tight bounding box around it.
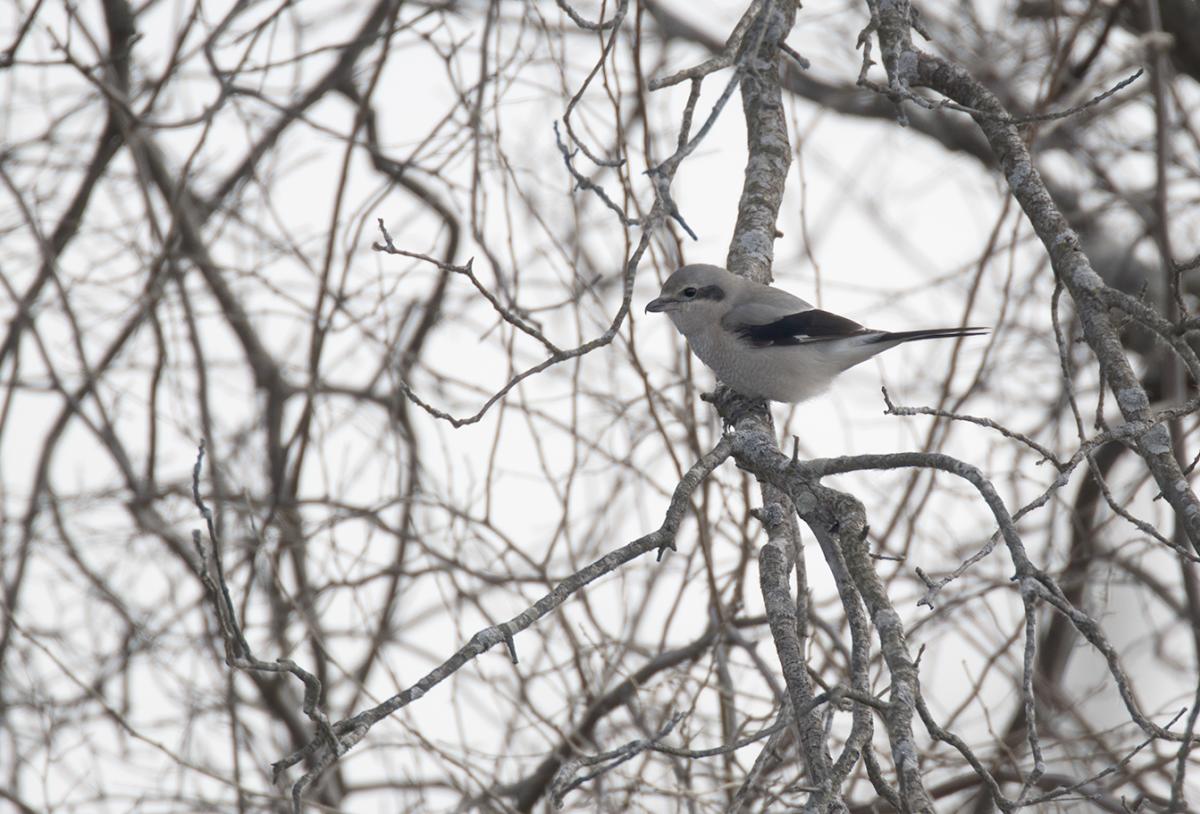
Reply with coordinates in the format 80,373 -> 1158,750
646,263 -> 988,403
